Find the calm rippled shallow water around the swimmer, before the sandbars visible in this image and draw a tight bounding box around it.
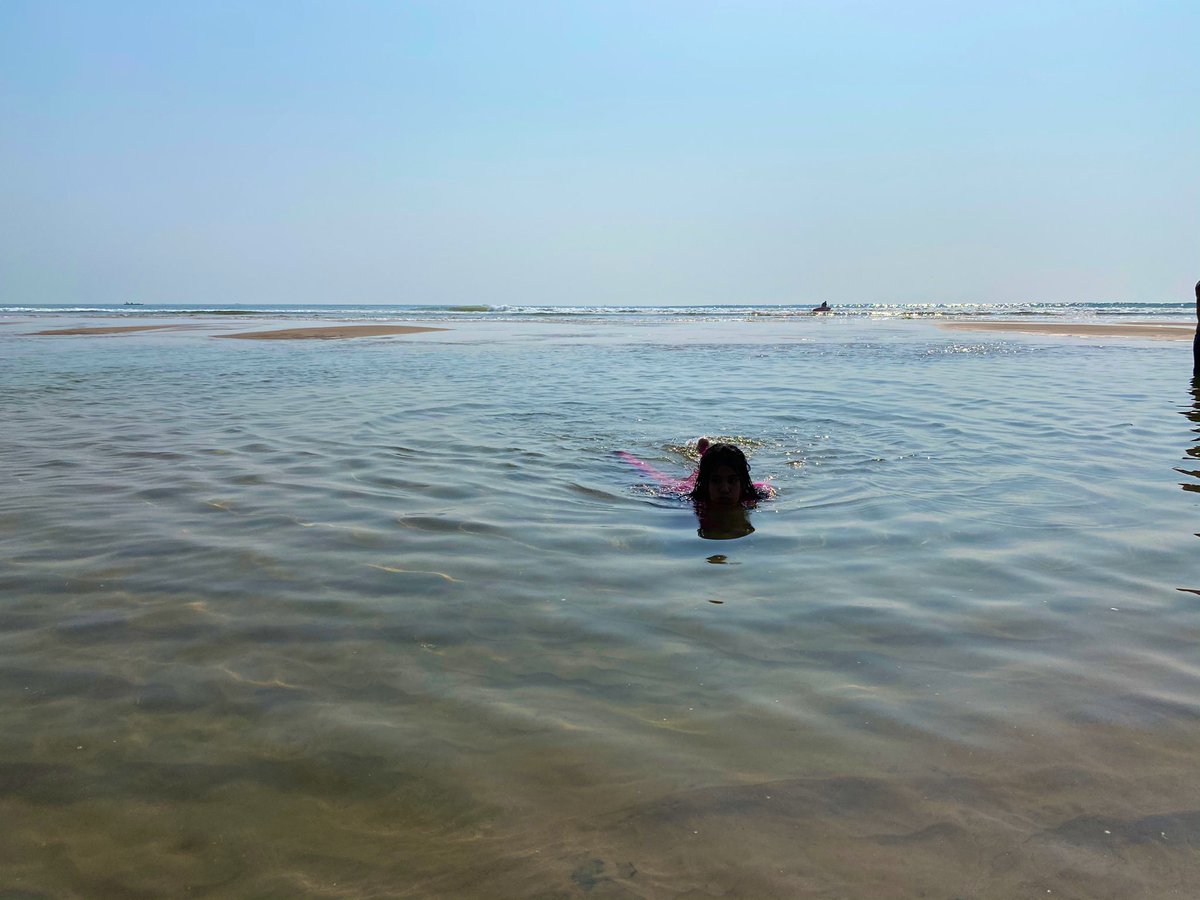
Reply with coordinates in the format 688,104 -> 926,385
0,320 -> 1200,898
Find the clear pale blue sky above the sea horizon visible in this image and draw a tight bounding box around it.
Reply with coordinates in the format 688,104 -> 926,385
0,0 -> 1200,306
